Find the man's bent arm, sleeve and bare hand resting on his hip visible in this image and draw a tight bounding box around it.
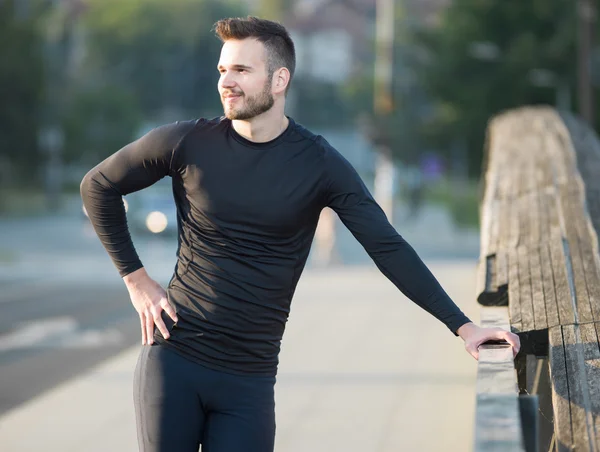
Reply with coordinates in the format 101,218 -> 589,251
81,121 -> 195,344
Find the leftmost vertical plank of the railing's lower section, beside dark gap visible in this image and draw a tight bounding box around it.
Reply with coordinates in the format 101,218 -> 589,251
548,326 -> 573,450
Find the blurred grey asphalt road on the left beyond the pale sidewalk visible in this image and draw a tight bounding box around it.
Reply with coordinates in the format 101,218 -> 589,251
0,205 -> 176,416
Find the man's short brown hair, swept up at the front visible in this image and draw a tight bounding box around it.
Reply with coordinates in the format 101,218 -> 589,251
214,16 -> 296,92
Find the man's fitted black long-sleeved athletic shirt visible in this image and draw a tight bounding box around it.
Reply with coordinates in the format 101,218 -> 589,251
81,118 -> 470,376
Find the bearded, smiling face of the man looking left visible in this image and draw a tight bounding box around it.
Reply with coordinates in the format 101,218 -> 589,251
217,39 -> 274,120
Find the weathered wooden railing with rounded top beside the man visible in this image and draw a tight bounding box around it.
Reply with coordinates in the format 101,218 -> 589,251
475,107 -> 600,451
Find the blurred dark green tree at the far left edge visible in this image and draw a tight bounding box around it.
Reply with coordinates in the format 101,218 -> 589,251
0,0 -> 43,185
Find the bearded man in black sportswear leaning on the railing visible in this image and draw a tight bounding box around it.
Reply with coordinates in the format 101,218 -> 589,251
81,17 -> 519,452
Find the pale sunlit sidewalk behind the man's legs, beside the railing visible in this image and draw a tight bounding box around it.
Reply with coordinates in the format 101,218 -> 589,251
0,260 -> 478,452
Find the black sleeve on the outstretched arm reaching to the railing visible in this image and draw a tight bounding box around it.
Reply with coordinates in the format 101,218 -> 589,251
325,142 -> 471,335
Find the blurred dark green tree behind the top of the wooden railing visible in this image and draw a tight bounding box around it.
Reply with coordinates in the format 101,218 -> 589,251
415,0 -> 577,176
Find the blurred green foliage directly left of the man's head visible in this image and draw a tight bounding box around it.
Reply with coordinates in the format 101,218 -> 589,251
65,0 -> 244,161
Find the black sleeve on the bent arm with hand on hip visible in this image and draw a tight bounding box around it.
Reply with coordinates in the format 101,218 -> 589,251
81,121 -> 196,276
